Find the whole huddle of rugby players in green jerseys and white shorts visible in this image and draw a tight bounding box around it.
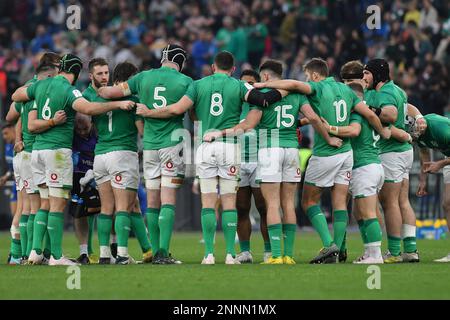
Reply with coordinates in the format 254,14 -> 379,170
4,45 -> 450,265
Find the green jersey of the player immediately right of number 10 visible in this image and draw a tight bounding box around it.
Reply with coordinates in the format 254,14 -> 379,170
350,112 -> 381,169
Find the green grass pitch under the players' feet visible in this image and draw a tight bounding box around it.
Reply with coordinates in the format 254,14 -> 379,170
0,232 -> 450,300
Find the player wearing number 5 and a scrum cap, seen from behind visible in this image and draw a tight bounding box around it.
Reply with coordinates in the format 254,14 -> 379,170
99,45 -> 192,264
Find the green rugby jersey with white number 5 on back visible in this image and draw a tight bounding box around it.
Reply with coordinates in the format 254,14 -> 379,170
127,67 -> 192,150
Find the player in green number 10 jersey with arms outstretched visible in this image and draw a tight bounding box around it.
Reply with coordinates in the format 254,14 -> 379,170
255,58 -> 390,263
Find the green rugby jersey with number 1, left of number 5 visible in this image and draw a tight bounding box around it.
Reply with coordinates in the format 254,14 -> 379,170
83,85 -> 139,155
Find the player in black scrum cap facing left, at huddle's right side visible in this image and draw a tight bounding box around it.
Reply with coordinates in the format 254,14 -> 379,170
363,59 -> 419,263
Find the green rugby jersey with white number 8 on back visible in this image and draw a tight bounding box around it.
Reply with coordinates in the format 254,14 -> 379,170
186,73 -> 251,142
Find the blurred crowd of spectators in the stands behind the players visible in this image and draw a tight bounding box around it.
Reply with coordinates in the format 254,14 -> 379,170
0,0 -> 450,117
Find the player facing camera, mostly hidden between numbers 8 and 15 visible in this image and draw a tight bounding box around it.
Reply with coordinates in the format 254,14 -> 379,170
236,70 -> 272,263
